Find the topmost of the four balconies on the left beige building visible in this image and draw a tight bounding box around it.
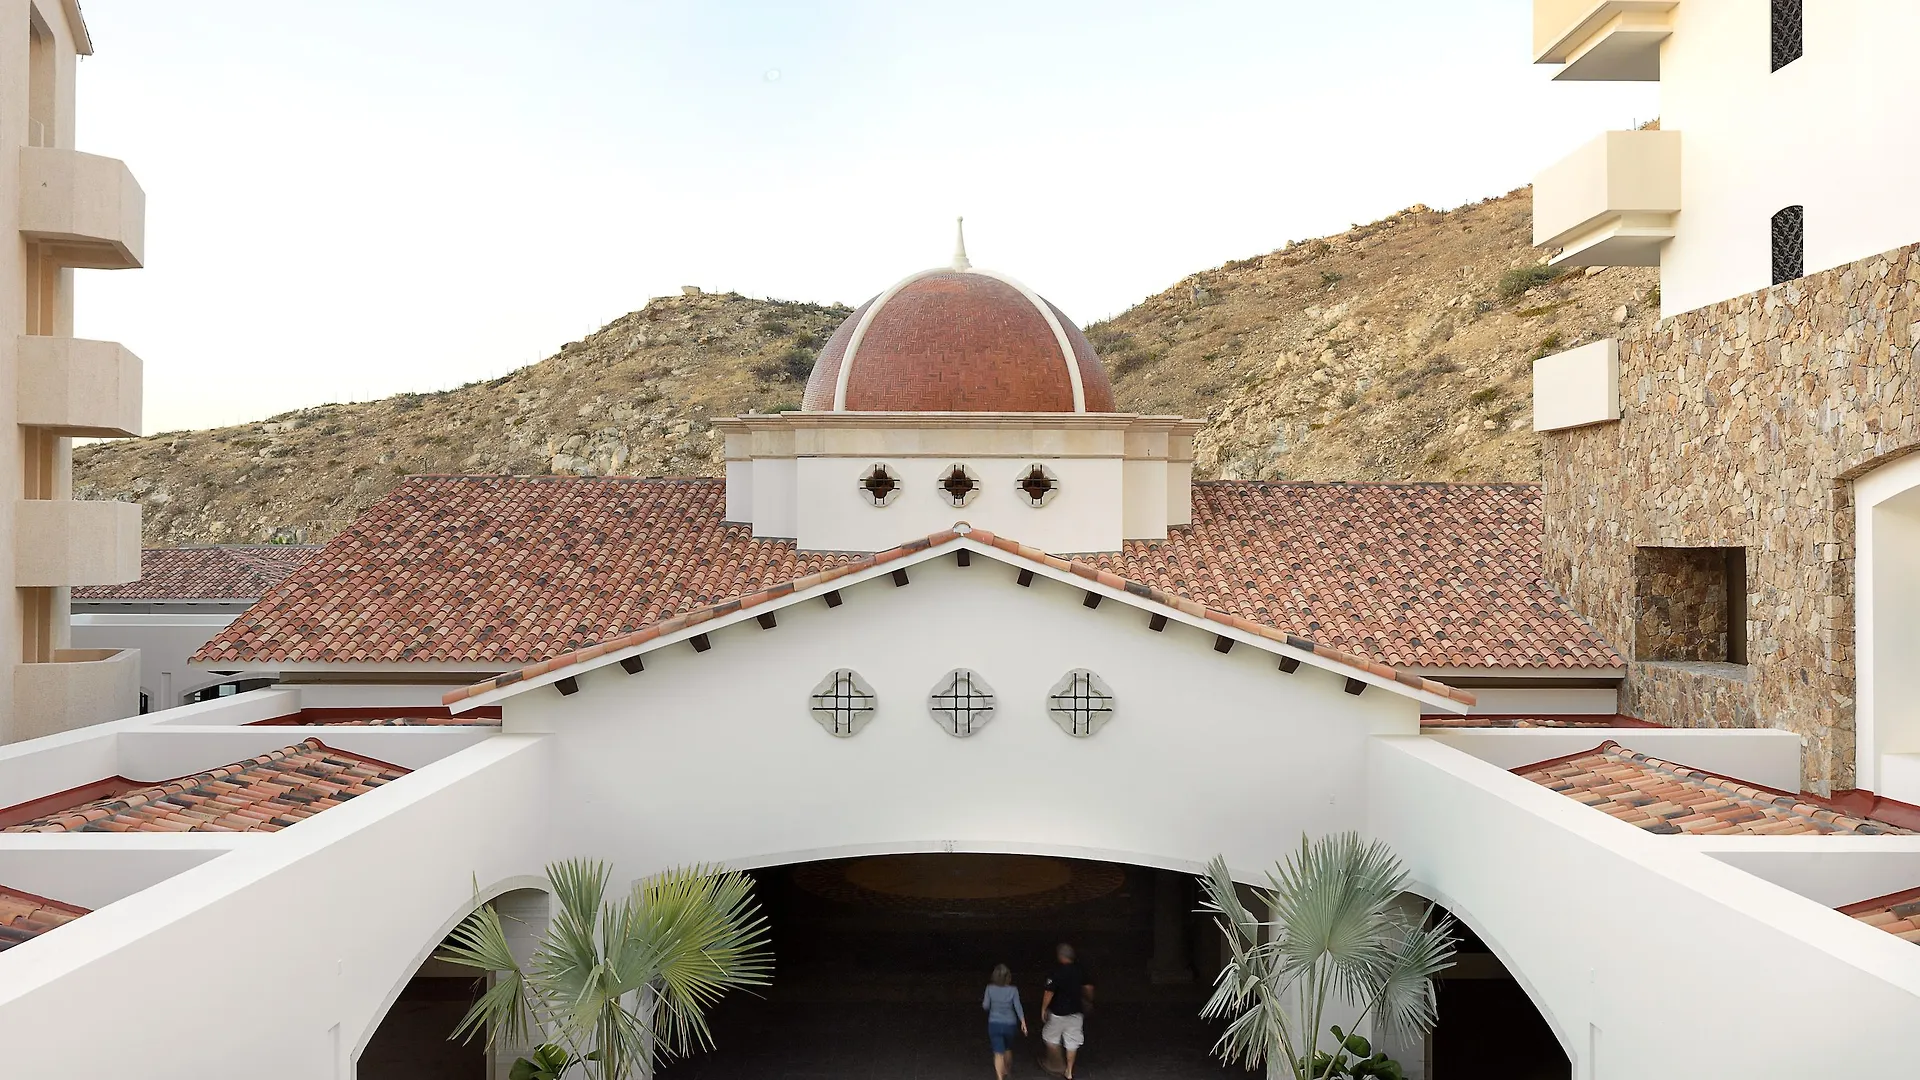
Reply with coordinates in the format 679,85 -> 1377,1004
19,146 -> 146,269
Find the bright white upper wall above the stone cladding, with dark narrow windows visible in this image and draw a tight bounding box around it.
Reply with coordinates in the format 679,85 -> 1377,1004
1661,0 -> 1920,315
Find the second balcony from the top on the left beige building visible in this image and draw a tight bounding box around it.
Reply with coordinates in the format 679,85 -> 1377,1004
17,334 -> 140,438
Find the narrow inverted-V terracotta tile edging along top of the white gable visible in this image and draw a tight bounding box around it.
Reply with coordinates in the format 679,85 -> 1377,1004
442,525 -> 1475,705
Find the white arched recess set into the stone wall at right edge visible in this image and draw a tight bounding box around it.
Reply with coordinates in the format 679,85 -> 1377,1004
1853,454 -> 1920,801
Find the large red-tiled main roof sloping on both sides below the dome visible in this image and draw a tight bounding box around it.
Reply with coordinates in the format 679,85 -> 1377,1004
196,477 -> 1620,669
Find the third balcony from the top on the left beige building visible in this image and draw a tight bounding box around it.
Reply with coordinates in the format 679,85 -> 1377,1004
13,500 -> 140,588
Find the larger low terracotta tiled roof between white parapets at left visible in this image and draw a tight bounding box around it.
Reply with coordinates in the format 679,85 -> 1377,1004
0,738 -> 407,832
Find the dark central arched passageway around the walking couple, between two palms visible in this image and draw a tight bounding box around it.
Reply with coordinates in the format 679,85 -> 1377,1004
662,853 -> 1238,1080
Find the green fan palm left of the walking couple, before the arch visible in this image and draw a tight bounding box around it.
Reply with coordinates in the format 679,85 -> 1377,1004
440,859 -> 774,1080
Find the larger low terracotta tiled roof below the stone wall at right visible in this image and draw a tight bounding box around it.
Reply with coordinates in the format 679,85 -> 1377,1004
1513,740 -> 1908,836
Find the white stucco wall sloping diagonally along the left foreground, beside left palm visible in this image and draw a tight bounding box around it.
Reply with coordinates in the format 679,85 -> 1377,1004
0,738 -> 551,1080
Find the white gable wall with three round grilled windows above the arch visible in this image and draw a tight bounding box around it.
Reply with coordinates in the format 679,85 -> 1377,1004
503,553 -> 1421,878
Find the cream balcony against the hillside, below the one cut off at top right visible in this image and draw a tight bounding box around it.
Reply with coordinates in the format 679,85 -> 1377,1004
1534,131 -> 1680,267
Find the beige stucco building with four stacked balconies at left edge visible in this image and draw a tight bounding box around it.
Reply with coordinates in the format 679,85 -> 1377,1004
0,0 -> 146,742
